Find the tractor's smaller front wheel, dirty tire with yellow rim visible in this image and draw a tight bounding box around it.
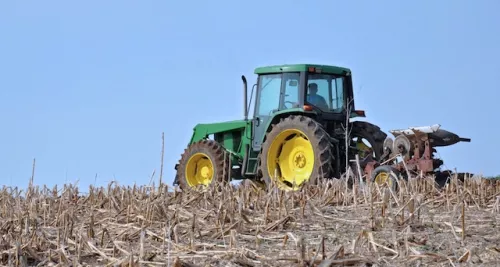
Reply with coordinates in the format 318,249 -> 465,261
176,139 -> 230,190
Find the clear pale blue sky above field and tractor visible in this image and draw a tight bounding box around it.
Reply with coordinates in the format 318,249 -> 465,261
0,0 -> 500,190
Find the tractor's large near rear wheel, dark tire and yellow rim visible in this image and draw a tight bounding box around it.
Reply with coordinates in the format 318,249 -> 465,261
260,115 -> 334,191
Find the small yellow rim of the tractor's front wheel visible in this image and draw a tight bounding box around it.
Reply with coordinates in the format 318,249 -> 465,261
186,153 -> 214,187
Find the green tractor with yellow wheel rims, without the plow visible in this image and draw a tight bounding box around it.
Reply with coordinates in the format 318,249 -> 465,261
174,64 -> 387,191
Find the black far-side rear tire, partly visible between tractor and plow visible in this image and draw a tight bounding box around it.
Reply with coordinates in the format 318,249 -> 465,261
351,121 -> 387,160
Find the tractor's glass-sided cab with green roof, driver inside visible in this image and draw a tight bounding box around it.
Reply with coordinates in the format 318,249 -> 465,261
252,64 -> 364,151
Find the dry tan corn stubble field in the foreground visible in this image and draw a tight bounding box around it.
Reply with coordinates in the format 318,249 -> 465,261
0,175 -> 500,266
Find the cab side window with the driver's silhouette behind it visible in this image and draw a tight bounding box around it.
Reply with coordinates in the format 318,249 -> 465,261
306,73 -> 345,112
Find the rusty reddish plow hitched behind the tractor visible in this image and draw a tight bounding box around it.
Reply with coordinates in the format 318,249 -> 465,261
363,124 -> 471,187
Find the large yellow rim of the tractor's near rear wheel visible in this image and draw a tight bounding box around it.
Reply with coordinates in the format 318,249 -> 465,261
266,129 -> 314,190
